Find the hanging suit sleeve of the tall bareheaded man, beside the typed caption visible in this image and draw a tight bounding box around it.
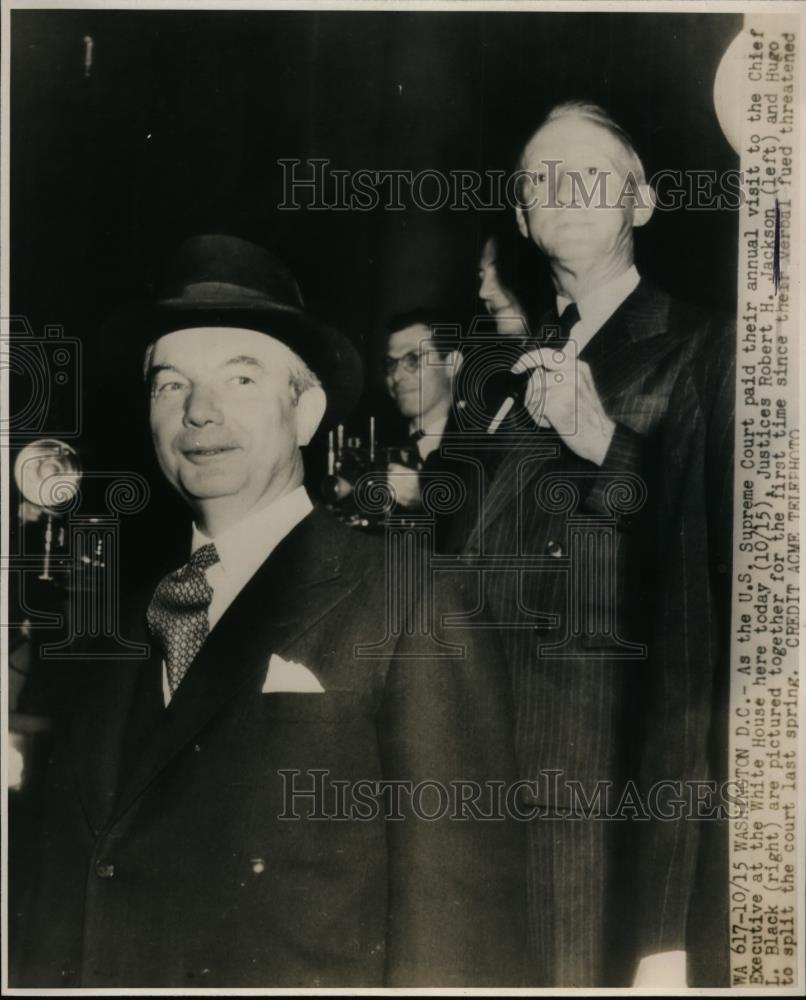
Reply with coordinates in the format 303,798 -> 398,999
637,326 -> 735,968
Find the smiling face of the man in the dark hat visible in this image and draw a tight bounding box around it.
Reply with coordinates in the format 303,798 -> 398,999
149,327 -> 306,532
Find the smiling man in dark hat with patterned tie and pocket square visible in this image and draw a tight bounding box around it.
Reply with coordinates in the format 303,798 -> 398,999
12,235 -> 525,989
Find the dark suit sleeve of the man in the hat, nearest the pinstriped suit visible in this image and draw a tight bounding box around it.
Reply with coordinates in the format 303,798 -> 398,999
379,577 -> 526,987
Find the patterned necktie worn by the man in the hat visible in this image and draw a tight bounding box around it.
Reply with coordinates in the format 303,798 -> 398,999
146,542 -> 218,694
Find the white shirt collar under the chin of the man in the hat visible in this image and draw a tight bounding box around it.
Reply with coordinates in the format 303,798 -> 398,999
190,486 -> 313,585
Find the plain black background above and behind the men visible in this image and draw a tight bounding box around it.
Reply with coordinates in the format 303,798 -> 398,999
11,11 -> 741,564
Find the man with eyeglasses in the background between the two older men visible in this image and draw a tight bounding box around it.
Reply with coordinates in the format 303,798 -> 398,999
383,308 -> 461,510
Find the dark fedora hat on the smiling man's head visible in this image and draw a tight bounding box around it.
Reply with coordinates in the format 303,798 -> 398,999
113,233 -> 363,423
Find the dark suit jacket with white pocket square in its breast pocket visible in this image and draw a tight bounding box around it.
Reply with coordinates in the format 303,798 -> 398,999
12,511 -> 525,988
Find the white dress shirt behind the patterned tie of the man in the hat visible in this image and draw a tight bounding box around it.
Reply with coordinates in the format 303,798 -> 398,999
162,486 -> 313,705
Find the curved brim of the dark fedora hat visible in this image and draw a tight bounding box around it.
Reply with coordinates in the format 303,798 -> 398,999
106,298 -> 363,426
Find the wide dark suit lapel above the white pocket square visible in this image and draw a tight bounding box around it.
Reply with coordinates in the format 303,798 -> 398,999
109,511 -> 361,816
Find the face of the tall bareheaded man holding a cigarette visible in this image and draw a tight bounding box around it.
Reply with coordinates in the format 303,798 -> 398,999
517,115 -> 651,270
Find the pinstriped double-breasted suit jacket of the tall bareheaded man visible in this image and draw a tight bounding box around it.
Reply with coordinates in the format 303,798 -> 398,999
465,282 -> 732,986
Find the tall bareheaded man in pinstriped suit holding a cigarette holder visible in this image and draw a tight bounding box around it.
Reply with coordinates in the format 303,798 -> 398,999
467,103 -> 733,986
